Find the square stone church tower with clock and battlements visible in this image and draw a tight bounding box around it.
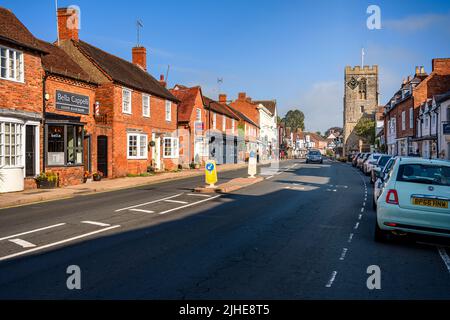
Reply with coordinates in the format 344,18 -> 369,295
344,65 -> 378,155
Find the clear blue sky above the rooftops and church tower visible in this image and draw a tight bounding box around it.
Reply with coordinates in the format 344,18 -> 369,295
0,0 -> 450,132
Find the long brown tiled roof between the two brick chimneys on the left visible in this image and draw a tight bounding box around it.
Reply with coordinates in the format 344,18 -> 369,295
72,41 -> 178,102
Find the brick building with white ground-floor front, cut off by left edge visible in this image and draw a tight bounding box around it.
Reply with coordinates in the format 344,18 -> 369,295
0,7 -> 47,192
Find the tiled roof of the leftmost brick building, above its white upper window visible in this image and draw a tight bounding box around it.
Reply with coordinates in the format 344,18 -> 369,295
0,7 -> 45,52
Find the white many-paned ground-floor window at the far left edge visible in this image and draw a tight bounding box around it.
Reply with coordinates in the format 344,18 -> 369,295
0,122 -> 23,167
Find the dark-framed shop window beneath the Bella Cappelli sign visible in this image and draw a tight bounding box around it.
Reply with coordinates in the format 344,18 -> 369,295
46,124 -> 84,166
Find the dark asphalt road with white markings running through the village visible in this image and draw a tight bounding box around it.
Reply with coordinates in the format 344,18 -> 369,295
0,160 -> 450,299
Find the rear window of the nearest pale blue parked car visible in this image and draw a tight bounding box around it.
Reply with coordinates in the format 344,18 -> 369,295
397,163 -> 450,186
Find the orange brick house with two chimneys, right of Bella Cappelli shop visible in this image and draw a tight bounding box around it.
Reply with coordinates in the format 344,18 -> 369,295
58,8 -> 179,177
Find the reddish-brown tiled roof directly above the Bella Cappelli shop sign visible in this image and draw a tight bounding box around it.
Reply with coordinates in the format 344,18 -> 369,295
38,40 -> 93,83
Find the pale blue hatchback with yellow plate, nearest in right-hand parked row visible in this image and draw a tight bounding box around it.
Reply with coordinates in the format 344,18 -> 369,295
375,158 -> 450,241
